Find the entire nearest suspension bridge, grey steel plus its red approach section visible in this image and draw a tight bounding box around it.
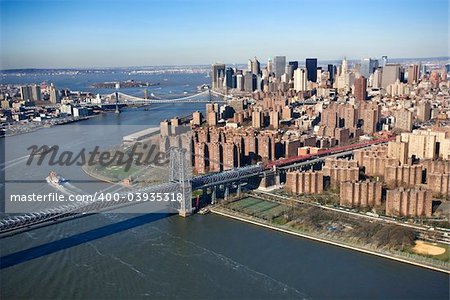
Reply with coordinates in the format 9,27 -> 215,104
0,138 -> 392,234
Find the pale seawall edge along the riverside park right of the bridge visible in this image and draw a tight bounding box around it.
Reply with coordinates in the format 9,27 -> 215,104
210,207 -> 450,274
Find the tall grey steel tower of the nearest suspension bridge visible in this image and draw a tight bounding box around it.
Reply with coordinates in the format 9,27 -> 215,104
169,148 -> 193,217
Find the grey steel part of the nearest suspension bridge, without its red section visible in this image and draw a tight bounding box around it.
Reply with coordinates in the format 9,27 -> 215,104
0,148 -> 263,234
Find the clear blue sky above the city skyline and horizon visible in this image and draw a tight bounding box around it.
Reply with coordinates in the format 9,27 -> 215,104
0,0 -> 449,69
